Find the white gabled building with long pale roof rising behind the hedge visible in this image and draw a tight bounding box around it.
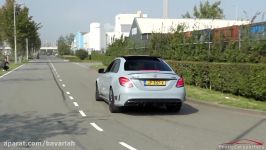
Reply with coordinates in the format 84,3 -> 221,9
129,18 -> 250,48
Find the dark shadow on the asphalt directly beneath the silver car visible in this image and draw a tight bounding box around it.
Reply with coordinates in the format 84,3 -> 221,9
123,103 -> 198,116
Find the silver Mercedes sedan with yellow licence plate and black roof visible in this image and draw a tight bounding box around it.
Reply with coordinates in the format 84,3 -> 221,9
95,56 -> 186,113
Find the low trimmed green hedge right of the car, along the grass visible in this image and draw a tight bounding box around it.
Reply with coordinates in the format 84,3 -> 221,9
168,61 -> 266,101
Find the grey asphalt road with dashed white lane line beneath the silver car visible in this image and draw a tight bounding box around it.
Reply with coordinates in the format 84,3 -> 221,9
0,56 -> 266,150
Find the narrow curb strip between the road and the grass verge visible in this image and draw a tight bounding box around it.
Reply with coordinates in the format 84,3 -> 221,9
187,97 -> 266,118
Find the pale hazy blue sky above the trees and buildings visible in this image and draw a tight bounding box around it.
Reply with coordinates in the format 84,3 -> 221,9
0,0 -> 266,42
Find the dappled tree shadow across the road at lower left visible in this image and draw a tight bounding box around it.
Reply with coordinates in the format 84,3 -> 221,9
0,112 -> 87,145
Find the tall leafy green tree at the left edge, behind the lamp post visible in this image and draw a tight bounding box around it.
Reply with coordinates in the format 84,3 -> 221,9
0,0 -> 41,56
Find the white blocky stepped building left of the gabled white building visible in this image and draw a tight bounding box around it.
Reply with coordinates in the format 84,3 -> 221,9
106,11 -> 148,45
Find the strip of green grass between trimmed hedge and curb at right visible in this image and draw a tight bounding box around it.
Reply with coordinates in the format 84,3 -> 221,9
186,85 -> 266,111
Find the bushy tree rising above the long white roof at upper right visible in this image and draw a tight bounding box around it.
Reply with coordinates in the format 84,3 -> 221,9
183,0 -> 224,19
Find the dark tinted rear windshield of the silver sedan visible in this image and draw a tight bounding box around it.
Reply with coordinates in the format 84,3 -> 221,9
124,57 -> 172,71
